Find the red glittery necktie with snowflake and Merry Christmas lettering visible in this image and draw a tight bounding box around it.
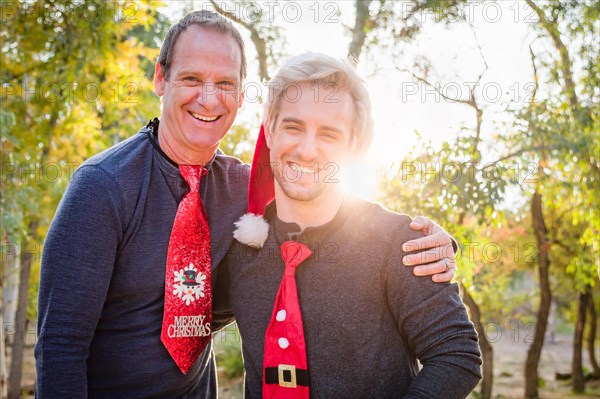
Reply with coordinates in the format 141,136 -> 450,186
160,165 -> 212,374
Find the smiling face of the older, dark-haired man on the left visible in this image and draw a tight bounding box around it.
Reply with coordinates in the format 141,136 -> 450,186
154,25 -> 242,159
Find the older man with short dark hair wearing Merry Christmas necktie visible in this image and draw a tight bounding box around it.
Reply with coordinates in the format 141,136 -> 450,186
35,11 -> 451,398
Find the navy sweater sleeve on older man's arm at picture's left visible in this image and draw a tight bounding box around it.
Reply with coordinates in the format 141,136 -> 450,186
35,165 -> 124,398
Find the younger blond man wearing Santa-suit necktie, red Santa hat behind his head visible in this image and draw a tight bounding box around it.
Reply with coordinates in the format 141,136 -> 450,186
213,53 -> 481,399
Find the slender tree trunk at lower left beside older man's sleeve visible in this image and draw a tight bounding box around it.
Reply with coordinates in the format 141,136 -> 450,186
8,220 -> 38,399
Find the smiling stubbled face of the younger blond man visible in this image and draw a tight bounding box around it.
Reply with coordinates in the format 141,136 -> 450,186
266,83 -> 354,205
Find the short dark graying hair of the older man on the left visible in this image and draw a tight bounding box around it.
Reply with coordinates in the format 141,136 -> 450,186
158,10 -> 247,80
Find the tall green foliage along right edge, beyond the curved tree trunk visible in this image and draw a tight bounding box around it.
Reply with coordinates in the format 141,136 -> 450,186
505,2 -> 600,298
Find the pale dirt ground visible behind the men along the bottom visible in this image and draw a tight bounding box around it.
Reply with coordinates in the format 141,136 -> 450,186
14,330 -> 600,399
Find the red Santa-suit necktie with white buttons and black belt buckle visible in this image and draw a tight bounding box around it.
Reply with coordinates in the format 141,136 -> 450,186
263,241 -> 312,399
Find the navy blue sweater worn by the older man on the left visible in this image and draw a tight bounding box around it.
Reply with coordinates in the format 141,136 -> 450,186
35,123 -> 249,398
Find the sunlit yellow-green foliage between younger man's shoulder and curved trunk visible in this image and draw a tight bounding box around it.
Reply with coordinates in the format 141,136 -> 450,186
380,134 -> 530,323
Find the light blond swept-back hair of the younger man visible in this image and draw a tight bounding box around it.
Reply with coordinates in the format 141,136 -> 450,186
263,52 -> 373,154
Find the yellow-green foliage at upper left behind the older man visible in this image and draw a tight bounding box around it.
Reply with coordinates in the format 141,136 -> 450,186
0,0 -> 166,316
